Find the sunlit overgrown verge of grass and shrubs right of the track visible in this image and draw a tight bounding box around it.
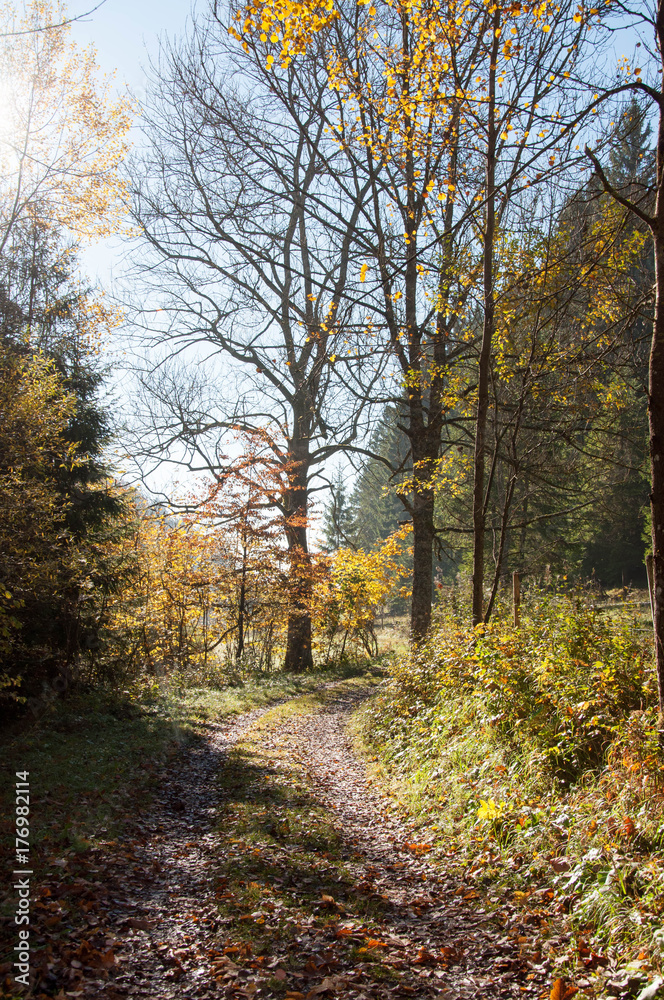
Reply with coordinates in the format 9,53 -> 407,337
357,598 -> 664,998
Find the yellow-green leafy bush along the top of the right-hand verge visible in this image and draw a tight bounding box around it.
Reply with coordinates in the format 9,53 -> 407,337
383,595 -> 655,783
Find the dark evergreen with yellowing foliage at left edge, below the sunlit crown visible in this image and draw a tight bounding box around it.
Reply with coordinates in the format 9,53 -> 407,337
0,220 -> 126,690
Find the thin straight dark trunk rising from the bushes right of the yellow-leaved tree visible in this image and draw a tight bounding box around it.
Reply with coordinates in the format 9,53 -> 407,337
473,8 -> 500,625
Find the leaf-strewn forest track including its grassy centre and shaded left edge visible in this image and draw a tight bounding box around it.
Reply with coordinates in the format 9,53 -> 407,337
0,674 -> 564,1000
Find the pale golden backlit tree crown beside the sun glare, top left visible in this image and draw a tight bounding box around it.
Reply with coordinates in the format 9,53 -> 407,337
0,0 -> 131,252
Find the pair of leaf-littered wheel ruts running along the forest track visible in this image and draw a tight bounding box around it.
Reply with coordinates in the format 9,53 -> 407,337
80,691 -> 543,1000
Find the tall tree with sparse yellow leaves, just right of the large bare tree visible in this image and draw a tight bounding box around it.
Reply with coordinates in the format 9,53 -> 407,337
328,4 -> 472,641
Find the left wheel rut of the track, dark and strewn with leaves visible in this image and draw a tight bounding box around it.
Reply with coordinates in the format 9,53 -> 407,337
90,709 -> 269,1000
